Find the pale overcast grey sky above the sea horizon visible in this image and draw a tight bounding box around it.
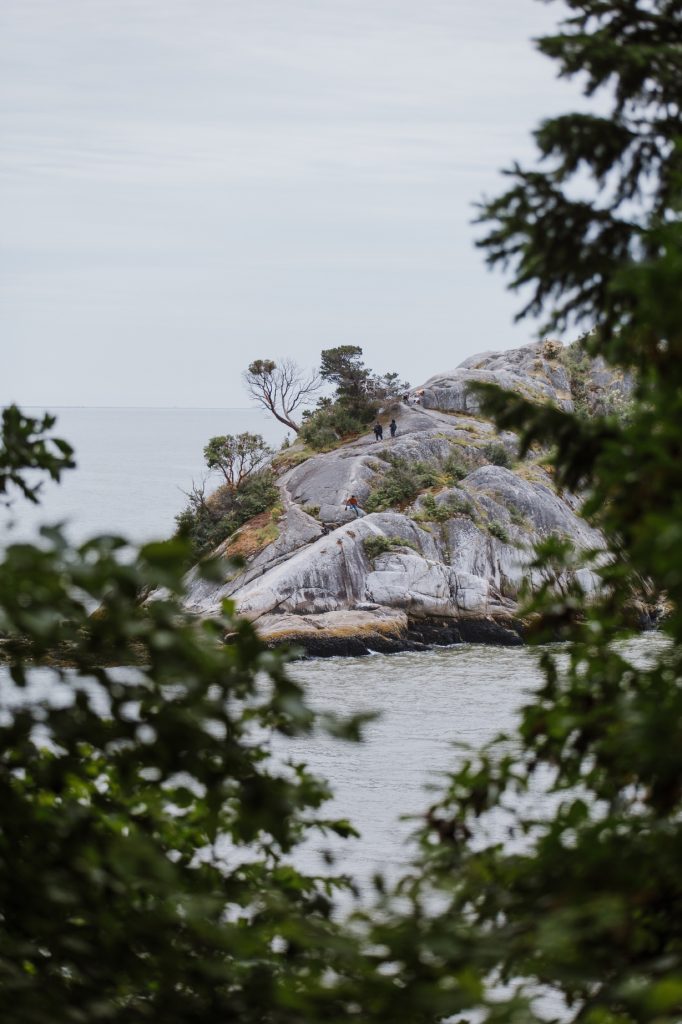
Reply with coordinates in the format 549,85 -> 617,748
0,0 -> 577,407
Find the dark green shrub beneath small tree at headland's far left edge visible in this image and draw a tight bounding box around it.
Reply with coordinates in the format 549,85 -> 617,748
175,469 -> 280,559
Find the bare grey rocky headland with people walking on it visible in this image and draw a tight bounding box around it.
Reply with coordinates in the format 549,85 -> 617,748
182,342 -> 629,656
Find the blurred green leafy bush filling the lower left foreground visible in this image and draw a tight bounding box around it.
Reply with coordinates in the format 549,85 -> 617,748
0,413 -> 357,1024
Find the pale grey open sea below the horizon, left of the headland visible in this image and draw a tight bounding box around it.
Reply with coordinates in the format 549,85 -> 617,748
0,409 -> 287,544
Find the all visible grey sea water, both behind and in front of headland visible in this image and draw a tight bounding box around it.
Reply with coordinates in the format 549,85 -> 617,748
0,409 -> 656,881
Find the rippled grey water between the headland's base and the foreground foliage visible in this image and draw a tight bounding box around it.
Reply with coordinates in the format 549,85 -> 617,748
284,644 -> 540,888
